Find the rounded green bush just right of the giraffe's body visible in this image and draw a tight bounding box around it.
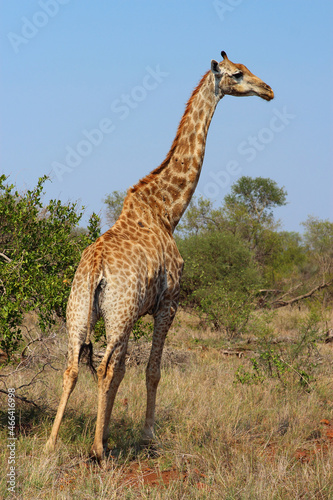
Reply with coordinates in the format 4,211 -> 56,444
179,231 -> 261,337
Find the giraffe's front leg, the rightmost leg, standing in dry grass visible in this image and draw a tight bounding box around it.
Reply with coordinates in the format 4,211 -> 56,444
142,303 -> 177,444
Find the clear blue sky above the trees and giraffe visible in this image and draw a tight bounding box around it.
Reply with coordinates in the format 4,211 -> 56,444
0,0 -> 333,231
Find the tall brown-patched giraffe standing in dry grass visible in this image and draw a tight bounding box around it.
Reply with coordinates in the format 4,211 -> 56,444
46,51 -> 274,461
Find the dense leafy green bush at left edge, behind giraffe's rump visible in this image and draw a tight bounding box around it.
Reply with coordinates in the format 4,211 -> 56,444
0,176 -> 99,357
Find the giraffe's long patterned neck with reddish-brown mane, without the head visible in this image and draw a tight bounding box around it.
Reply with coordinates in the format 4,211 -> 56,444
124,71 -> 218,231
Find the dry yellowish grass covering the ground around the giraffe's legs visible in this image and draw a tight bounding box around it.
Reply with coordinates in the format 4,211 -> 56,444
0,310 -> 333,500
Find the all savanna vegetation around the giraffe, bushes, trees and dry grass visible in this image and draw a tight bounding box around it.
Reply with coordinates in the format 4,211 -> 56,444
0,176 -> 333,499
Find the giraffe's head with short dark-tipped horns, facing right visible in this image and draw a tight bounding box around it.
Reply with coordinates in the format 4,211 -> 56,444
211,51 -> 274,101
